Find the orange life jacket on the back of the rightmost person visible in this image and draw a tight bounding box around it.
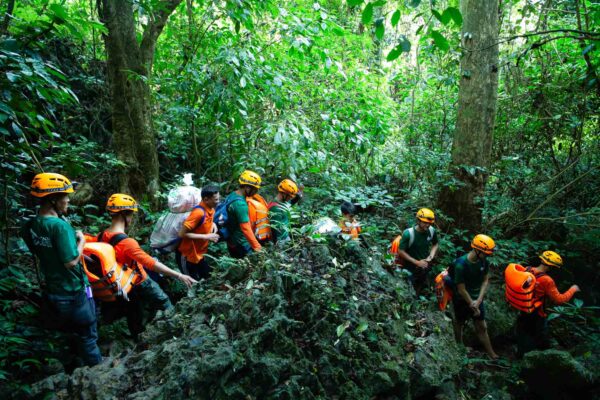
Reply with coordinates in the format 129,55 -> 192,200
504,264 -> 543,314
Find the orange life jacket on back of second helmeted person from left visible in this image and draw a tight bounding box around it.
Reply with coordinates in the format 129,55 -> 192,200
82,242 -> 138,301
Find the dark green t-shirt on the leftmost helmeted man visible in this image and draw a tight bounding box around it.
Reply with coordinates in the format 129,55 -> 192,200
22,216 -> 89,295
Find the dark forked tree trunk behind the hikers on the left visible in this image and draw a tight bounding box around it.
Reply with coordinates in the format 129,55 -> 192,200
97,0 -> 182,200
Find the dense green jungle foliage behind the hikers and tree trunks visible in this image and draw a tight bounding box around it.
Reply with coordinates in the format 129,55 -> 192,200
0,0 -> 600,396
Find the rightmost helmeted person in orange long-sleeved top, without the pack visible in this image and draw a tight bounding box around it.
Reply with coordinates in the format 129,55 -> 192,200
517,250 -> 581,357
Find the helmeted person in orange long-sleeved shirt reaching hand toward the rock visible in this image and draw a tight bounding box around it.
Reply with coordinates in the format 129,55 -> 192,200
90,193 -> 196,340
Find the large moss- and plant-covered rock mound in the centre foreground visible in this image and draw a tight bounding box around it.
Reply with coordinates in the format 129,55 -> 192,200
33,241 -> 464,399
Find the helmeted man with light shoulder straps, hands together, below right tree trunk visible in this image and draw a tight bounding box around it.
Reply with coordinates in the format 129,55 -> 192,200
397,208 -> 439,297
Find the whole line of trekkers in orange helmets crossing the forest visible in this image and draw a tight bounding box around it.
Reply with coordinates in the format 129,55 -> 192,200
22,170 -> 579,366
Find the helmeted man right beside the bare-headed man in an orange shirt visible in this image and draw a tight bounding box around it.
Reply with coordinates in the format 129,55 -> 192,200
223,170 -> 262,258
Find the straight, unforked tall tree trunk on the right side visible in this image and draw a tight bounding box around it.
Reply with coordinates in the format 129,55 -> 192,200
439,0 -> 498,232
